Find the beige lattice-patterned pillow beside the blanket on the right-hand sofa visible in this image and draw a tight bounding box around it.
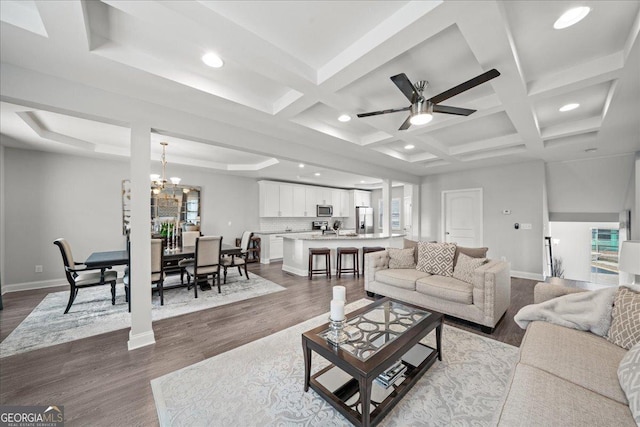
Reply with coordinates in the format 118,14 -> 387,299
607,286 -> 640,350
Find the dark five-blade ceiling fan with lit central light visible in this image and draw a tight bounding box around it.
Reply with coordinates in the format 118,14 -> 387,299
358,68 -> 500,130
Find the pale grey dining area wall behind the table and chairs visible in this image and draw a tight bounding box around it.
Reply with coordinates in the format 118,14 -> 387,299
2,147 -> 258,292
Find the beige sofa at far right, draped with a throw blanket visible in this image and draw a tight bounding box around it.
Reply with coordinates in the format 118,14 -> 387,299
497,283 -> 636,427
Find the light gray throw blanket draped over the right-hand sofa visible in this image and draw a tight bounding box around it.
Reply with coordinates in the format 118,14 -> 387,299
513,286 -> 618,337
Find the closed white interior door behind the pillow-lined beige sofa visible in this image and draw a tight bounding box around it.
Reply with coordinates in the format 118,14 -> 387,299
442,188 -> 483,247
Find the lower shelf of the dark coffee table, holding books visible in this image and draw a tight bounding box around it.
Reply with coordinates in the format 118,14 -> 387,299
309,343 -> 438,426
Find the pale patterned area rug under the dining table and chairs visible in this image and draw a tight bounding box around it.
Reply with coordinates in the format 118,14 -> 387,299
0,269 -> 285,358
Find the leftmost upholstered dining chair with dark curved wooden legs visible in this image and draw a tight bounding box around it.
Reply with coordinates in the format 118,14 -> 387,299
53,239 -> 118,314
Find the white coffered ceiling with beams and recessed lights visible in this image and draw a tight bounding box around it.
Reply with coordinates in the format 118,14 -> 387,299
0,0 -> 640,187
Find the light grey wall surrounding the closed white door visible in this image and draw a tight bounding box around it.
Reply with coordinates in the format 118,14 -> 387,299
421,161 -> 545,279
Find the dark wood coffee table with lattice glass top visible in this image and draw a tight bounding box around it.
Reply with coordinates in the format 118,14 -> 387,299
302,298 -> 443,426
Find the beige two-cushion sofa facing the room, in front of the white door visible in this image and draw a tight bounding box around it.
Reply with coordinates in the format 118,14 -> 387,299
364,246 -> 511,333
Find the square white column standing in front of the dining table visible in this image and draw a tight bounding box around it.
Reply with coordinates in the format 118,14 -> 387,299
128,123 -> 156,350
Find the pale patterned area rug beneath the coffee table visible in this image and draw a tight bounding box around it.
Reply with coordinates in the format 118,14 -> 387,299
151,300 -> 518,427
